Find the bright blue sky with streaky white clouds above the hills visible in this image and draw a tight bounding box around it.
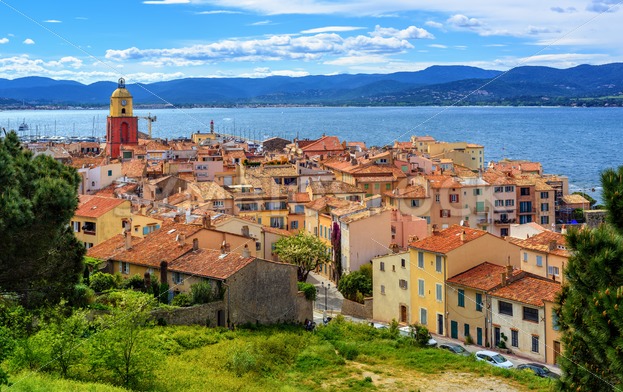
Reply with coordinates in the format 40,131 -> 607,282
0,0 -> 623,84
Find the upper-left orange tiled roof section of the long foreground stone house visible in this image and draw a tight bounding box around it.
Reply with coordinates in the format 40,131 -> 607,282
114,222 -> 202,267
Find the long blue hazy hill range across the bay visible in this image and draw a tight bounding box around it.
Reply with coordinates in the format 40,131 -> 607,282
0,63 -> 623,107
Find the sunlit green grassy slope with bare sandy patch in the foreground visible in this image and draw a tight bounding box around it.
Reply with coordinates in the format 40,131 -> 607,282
2,322 -> 551,392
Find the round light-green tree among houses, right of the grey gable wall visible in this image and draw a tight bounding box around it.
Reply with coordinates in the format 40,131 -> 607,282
274,231 -> 331,282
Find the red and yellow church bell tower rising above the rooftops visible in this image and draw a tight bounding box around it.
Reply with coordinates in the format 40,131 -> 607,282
106,78 -> 138,158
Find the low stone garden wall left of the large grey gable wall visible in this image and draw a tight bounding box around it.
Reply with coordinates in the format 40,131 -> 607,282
152,301 -> 227,327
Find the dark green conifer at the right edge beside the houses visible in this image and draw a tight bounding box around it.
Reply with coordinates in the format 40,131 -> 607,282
556,167 -> 623,391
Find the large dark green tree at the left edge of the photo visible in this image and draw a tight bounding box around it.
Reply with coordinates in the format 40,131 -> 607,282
0,132 -> 85,307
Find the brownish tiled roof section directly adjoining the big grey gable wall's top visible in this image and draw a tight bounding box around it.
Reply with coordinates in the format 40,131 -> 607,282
168,249 -> 256,279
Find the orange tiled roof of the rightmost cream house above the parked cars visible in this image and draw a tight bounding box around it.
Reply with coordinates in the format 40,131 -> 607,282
491,274 -> 560,306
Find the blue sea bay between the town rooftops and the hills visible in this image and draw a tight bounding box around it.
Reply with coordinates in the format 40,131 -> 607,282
0,106 -> 623,200
